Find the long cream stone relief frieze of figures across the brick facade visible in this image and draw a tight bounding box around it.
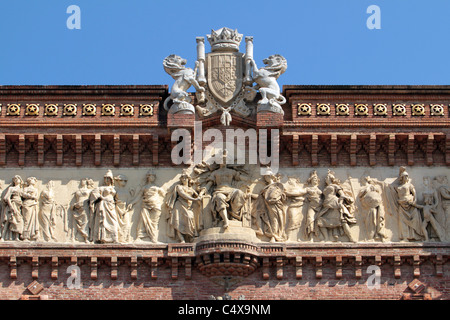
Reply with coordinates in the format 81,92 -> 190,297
0,166 -> 450,245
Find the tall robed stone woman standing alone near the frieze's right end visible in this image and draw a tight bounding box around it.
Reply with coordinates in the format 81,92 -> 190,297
387,167 -> 423,241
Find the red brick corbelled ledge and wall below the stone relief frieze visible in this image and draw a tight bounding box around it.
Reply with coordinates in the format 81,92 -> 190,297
0,241 -> 444,299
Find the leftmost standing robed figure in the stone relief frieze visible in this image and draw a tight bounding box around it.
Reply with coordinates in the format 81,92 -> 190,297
1,175 -> 23,240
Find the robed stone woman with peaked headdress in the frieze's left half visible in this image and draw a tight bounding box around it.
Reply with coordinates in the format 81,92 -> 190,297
89,170 -> 119,243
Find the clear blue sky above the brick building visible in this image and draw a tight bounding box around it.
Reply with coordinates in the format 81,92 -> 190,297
0,0 -> 450,85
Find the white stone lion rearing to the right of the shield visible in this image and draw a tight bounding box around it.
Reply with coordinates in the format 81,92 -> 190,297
246,54 -> 287,114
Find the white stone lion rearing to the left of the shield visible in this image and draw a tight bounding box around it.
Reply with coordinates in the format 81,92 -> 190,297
163,54 -> 205,113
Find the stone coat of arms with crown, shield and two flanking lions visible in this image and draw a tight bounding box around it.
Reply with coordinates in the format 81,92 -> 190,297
164,28 -> 287,126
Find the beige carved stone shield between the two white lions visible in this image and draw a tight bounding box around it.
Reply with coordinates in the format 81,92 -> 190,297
207,52 -> 244,105
